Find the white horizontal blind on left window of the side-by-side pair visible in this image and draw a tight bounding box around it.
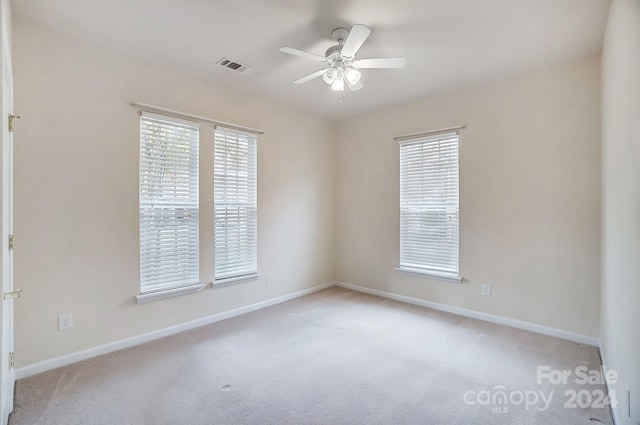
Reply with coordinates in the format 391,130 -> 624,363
140,112 -> 199,293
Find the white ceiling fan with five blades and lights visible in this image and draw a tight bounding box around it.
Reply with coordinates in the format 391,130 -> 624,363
280,24 -> 407,92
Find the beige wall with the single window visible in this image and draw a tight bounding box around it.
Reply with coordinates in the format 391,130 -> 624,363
336,56 -> 600,337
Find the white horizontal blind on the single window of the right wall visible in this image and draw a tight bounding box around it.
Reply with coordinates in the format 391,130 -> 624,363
400,133 -> 459,275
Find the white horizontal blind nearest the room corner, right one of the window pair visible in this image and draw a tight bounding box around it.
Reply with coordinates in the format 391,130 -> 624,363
213,127 -> 258,280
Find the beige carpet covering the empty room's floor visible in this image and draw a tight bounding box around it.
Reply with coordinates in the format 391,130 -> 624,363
9,288 -> 612,425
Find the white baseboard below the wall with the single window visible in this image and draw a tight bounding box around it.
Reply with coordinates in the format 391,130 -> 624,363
334,282 -> 600,347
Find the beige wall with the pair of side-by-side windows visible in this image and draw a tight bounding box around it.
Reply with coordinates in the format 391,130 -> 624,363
14,22 -> 333,367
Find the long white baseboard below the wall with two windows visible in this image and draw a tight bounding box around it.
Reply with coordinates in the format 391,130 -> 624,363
15,282 -> 334,380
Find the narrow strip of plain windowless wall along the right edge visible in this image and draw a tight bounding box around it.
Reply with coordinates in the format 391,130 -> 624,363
601,0 -> 640,425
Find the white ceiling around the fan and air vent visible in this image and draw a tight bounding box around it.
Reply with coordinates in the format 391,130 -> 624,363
12,0 -> 610,118
